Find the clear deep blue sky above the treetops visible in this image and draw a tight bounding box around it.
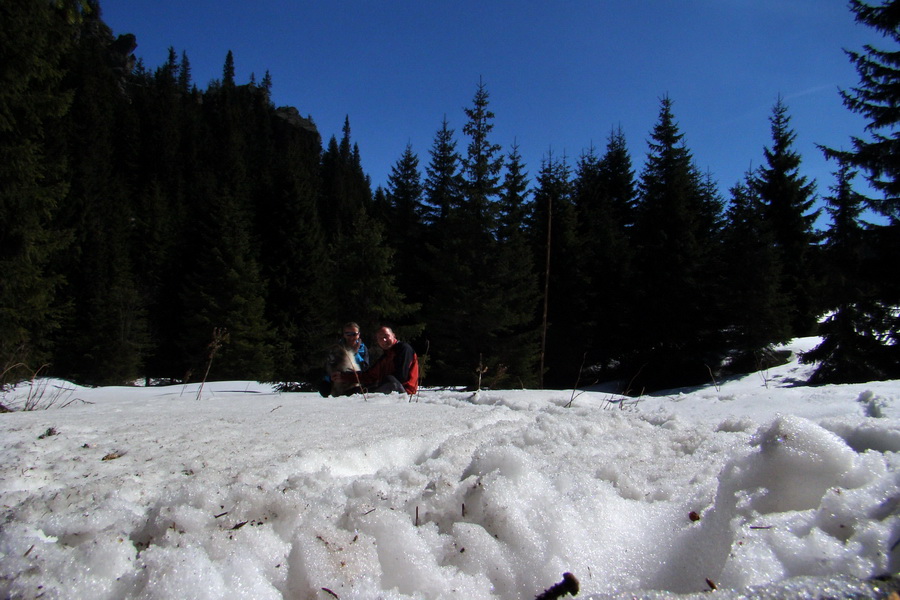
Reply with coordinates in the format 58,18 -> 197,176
102,0 -> 886,207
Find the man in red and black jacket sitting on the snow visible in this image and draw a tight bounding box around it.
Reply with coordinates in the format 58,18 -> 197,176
332,327 -> 419,395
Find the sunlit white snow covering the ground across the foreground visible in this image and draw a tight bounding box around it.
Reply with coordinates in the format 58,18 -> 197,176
0,340 -> 900,600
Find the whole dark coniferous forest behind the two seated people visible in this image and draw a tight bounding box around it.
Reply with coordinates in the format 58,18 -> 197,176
0,0 -> 900,394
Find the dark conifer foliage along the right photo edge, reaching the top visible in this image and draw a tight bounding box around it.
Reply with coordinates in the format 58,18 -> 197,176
810,0 -> 900,381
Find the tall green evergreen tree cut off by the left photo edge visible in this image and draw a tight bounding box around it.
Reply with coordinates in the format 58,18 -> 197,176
0,2 -> 74,384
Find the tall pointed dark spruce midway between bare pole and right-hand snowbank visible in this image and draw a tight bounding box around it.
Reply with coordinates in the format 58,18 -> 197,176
630,97 -> 718,392
